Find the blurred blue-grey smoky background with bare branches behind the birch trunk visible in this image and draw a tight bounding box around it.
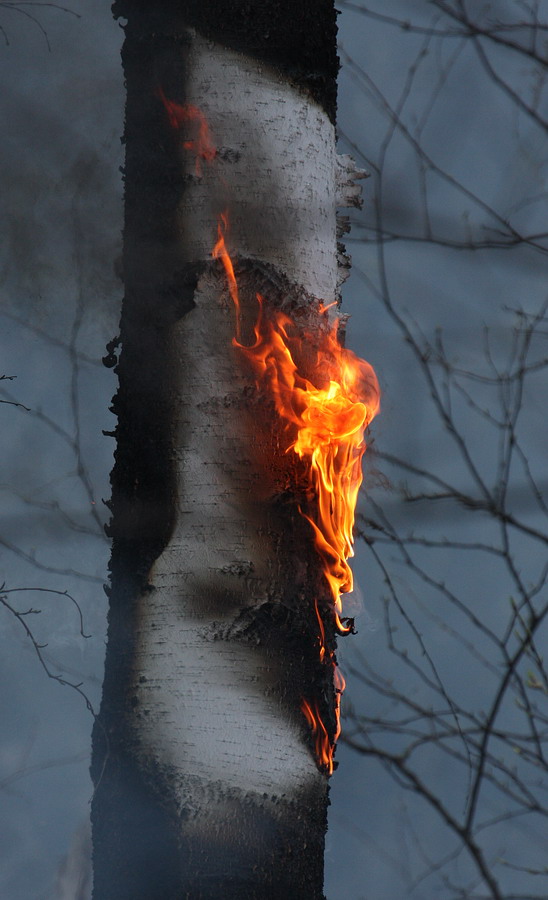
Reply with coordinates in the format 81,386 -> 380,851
0,0 -> 548,900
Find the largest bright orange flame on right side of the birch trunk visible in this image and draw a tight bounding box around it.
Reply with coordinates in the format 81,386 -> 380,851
212,213 -> 379,633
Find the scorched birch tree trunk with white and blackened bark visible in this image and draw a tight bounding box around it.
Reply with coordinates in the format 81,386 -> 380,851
92,0 -> 360,900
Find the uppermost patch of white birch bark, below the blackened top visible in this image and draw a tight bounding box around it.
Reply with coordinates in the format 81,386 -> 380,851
176,35 -> 336,299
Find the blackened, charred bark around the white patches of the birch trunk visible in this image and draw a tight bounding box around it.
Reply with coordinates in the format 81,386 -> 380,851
92,0 -> 337,900
